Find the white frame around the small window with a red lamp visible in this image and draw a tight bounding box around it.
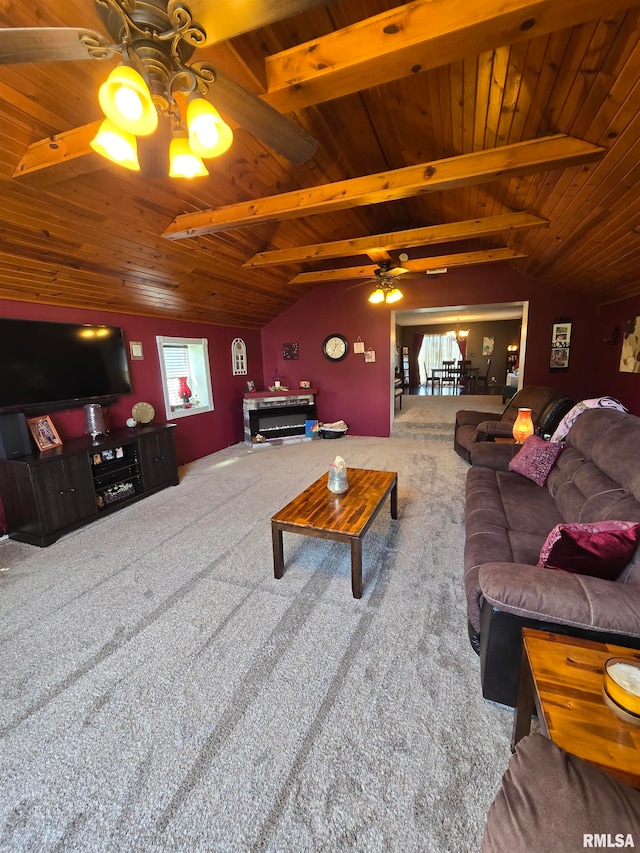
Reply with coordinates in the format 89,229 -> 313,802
156,335 -> 214,421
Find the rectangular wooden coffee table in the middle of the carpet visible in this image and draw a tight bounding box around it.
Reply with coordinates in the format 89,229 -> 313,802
271,468 -> 398,598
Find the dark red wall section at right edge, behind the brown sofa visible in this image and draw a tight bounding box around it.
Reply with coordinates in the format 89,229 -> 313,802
594,296 -> 640,415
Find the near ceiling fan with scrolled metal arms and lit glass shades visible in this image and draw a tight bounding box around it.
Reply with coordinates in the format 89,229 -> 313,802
0,0 -> 327,177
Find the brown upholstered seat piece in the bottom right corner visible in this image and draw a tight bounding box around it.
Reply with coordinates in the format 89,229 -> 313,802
482,734 -> 640,853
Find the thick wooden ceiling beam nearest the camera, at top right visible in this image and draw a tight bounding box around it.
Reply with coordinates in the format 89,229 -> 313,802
264,0 -> 640,112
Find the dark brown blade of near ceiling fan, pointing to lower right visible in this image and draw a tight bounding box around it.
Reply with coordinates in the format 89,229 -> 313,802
200,63 -> 318,165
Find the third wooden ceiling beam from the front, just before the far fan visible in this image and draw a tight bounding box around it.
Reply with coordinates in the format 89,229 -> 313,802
243,213 -> 549,267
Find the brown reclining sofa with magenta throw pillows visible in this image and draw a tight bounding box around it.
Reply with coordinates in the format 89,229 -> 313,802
464,408 -> 640,706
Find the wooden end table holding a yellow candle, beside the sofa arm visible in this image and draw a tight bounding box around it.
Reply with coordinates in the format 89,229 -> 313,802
513,628 -> 640,789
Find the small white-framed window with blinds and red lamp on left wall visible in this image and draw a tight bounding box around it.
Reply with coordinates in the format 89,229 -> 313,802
156,335 -> 213,420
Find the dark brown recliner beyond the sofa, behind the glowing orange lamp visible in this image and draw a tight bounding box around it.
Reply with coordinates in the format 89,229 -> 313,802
453,385 -> 574,462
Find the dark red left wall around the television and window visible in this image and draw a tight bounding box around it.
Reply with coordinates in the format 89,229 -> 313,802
0,300 -> 262,465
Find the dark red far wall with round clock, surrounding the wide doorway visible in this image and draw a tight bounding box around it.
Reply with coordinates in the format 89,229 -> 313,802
262,264 -> 598,436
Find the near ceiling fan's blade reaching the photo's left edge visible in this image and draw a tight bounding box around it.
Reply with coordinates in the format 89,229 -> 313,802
0,27 -> 110,65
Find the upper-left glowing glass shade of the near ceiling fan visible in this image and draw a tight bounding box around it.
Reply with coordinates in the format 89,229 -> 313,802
98,65 -> 158,136
